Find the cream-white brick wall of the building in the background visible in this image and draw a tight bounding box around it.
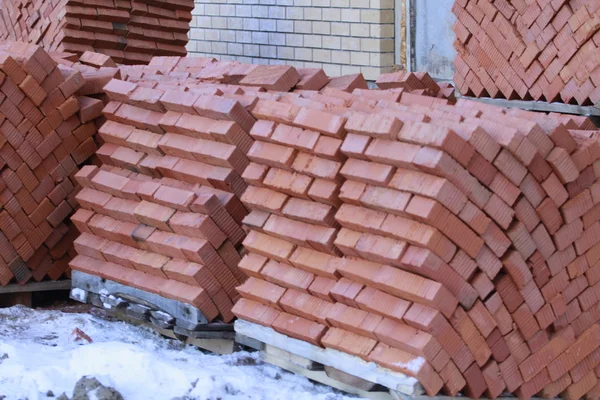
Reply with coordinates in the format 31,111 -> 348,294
188,0 -> 395,80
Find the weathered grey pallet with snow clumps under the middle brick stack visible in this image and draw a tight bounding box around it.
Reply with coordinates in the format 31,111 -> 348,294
71,270 -> 236,354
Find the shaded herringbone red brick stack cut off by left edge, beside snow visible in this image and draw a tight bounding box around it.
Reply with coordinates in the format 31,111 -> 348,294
0,43 -> 102,286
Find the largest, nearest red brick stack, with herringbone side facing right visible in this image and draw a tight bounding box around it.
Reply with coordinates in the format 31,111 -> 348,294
227,68 -> 600,399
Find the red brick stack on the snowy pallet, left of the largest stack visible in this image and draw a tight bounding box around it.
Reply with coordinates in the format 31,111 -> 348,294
71,61 -> 449,321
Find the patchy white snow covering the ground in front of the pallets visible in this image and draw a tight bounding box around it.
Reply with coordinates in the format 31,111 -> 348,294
0,306 -> 350,400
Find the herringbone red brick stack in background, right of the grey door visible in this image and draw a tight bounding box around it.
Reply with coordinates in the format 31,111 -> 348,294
453,0 -> 600,105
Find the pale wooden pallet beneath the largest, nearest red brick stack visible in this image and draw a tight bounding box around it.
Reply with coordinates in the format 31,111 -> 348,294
235,320 -> 556,400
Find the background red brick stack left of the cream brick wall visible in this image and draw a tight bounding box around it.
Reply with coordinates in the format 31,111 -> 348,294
0,0 -> 194,64
